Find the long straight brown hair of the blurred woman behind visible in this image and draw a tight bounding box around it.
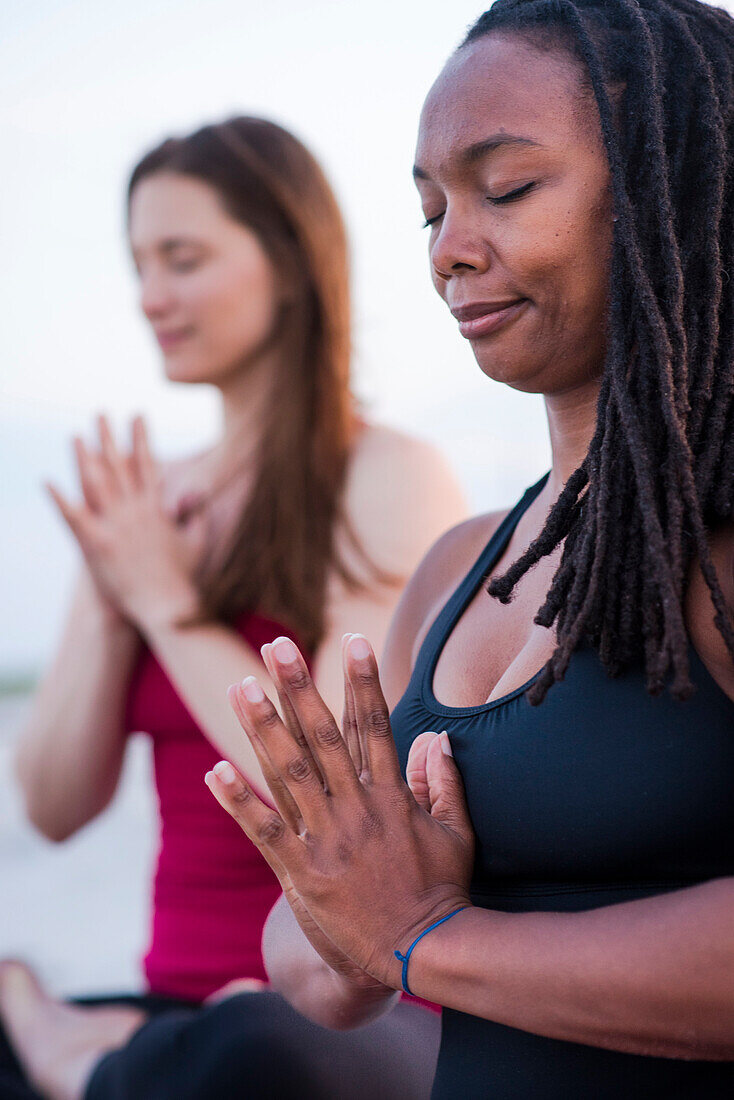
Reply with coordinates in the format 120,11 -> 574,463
128,118 -> 365,652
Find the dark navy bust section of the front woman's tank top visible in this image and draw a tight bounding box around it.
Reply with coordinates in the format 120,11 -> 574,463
393,649 -> 734,893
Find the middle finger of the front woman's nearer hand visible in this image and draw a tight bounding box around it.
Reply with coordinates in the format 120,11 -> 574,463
270,638 -> 360,794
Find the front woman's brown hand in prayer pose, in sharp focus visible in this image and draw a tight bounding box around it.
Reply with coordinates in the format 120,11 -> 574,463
207,635 -> 474,989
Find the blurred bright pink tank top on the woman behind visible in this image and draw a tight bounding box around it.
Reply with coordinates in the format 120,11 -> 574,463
125,614 -> 310,1001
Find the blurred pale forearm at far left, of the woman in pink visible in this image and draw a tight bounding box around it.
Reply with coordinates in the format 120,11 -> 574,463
17,579 -> 140,840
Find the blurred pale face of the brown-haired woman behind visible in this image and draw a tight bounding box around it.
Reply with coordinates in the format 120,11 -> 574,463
130,172 -> 278,385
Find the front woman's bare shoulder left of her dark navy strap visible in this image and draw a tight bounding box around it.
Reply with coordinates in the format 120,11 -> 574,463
383,509 -> 507,704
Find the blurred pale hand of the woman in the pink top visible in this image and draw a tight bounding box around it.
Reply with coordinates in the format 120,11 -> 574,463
48,417 -> 205,634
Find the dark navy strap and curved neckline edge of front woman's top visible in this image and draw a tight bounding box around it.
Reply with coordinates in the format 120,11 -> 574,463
420,472 -> 550,717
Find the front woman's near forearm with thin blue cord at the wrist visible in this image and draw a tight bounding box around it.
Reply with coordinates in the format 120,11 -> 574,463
407,879 -> 734,1060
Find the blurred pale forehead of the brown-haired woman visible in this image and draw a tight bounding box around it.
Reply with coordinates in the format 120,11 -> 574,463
130,172 -> 231,243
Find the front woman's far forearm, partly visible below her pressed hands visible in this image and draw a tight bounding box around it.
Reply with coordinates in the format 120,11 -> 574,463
263,897 -> 397,1030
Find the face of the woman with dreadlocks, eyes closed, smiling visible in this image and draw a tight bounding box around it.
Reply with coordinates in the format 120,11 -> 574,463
415,34 -> 612,394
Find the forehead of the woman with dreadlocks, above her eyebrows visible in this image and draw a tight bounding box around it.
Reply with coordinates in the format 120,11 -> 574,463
416,33 -> 599,175
